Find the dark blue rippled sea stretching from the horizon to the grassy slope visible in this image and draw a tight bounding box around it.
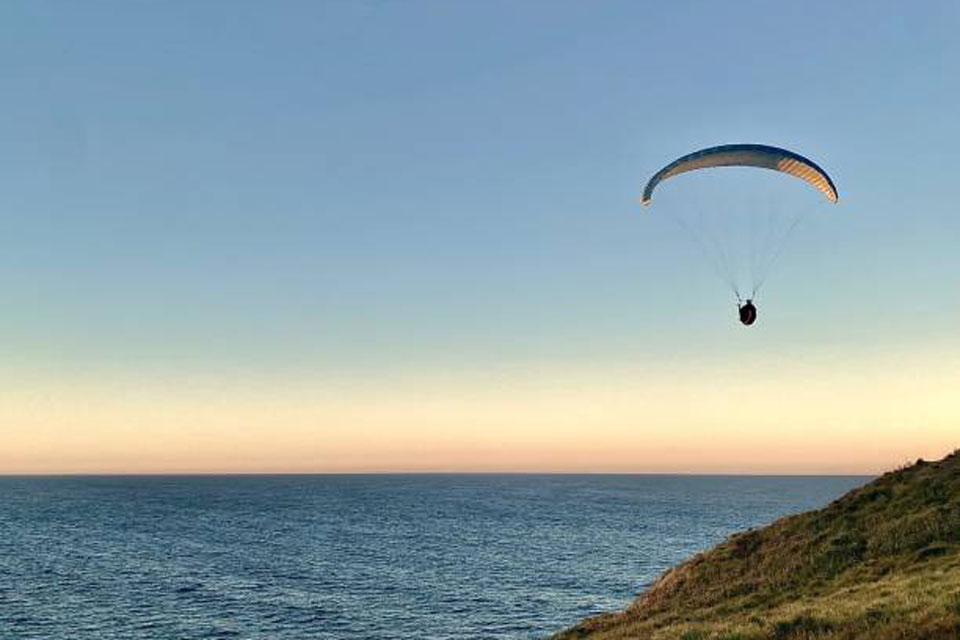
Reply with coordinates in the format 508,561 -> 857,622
0,475 -> 866,640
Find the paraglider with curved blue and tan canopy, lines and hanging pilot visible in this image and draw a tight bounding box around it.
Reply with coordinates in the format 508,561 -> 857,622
641,144 -> 839,326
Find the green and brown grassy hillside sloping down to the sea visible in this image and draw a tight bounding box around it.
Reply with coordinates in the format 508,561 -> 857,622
554,451 -> 960,640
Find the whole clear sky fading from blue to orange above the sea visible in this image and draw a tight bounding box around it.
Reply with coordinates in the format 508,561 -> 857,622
0,0 -> 960,474
